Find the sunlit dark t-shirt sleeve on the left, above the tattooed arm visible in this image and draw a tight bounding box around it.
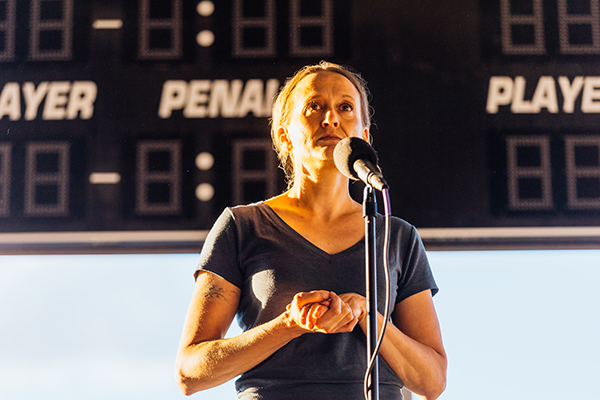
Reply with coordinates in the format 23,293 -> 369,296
194,208 -> 243,288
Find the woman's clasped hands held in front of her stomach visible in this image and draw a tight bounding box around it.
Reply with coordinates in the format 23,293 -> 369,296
286,290 -> 366,333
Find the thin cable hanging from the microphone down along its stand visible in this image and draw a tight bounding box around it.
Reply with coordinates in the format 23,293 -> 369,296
363,188 -> 392,400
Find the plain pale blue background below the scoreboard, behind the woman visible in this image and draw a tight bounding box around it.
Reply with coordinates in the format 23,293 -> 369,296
0,250 -> 600,400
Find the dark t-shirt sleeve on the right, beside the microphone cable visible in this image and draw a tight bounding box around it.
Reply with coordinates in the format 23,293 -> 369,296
396,226 -> 438,304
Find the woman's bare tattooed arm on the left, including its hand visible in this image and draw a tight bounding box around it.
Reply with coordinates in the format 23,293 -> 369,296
175,272 -> 357,395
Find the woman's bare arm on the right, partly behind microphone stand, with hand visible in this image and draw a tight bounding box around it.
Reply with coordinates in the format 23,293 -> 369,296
341,290 -> 447,400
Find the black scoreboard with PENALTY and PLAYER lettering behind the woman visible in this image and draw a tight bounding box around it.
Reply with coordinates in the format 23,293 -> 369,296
0,0 -> 600,254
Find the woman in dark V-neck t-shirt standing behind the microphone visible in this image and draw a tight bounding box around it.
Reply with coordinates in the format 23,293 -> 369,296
176,62 -> 446,400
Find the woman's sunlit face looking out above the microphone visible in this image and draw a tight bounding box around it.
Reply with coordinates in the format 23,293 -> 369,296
278,71 -> 369,171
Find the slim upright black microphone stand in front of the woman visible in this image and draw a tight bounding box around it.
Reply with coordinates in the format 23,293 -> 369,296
363,184 -> 379,400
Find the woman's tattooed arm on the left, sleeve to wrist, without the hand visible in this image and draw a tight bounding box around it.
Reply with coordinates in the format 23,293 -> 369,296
175,272 -> 301,395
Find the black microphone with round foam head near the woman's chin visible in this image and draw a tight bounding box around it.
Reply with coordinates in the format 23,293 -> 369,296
333,137 -> 389,191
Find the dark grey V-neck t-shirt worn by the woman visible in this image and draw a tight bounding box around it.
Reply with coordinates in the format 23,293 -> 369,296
197,202 -> 437,400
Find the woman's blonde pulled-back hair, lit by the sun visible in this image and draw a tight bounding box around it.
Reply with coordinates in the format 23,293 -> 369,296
271,61 -> 372,188
